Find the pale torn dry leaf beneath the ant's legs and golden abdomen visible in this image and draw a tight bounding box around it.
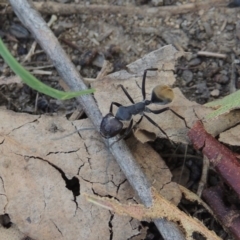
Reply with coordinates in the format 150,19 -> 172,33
92,45 -> 240,144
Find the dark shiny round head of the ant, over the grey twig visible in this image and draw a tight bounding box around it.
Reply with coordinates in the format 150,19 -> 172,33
100,113 -> 123,138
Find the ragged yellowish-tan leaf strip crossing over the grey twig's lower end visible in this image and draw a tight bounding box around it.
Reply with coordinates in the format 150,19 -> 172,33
85,188 -> 220,240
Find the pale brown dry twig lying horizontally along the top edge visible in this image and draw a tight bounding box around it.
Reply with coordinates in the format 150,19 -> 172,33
1,0 -> 226,17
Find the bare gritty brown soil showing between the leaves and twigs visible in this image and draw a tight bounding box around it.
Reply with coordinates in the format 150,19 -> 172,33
0,0 -> 240,239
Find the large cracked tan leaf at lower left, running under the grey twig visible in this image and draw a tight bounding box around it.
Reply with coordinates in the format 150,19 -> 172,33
0,110 -> 180,240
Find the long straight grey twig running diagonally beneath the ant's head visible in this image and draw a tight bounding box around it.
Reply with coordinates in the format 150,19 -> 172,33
7,0 -> 184,239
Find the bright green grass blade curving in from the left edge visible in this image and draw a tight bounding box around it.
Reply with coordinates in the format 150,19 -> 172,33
0,38 -> 95,100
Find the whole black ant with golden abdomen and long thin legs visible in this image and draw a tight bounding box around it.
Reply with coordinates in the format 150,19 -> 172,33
100,68 -> 185,141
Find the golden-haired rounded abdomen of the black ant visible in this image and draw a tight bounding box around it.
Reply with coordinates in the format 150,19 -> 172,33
151,85 -> 174,105
